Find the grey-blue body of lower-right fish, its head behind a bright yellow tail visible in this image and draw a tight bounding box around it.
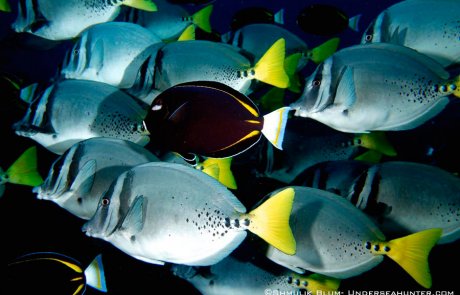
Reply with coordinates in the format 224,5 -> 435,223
267,186 -> 385,279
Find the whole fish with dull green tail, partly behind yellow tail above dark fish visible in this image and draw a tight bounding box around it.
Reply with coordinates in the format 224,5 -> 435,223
223,23 -> 340,71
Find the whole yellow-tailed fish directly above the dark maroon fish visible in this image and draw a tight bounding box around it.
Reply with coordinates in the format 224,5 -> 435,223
134,38 -> 289,101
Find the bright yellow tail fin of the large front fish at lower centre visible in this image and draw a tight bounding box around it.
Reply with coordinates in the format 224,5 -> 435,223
247,188 -> 296,255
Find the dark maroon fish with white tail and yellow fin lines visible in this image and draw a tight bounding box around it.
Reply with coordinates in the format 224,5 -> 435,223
143,81 -> 290,158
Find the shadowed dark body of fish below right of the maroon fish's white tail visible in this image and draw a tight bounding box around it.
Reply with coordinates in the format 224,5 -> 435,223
261,117 -> 362,183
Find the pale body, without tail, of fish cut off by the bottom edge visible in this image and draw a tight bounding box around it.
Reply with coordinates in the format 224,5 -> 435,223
172,256 -> 300,295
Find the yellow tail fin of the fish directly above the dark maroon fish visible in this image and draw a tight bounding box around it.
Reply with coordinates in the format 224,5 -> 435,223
254,38 -> 289,88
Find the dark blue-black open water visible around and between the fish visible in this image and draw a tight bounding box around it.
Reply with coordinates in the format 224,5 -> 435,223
0,0 -> 460,295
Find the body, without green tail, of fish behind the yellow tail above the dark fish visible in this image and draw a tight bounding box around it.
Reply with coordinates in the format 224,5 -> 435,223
223,23 -> 310,70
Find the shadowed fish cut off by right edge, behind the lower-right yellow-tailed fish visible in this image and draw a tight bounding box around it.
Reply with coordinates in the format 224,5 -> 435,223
292,161 -> 460,244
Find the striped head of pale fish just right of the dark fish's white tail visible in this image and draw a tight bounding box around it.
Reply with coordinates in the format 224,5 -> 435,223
289,58 -> 334,118
